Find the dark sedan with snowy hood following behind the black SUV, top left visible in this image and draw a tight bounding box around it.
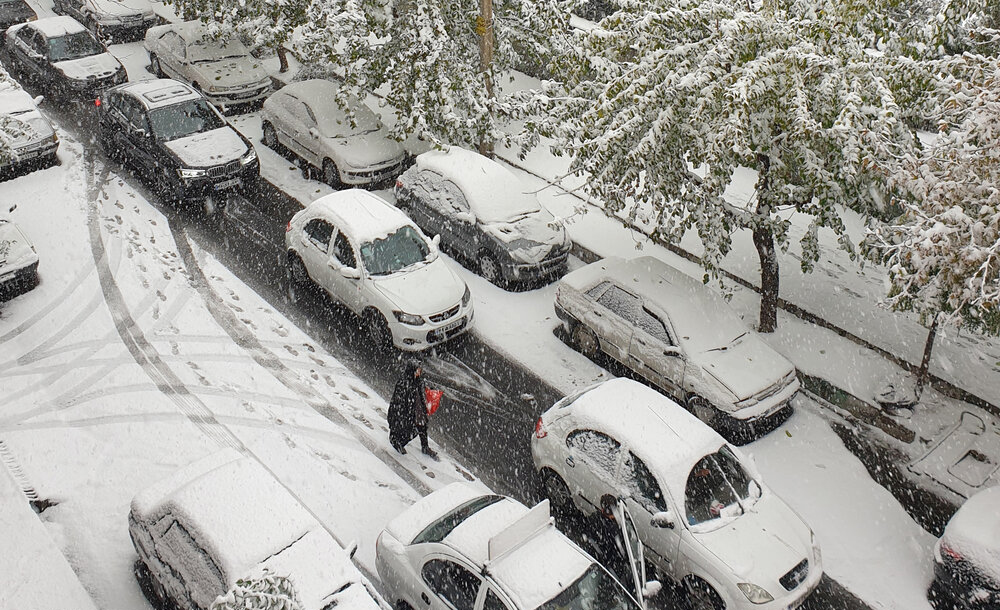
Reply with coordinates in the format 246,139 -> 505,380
4,16 -> 128,99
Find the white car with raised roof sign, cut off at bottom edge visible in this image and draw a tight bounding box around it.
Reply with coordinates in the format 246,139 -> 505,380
375,483 -> 644,610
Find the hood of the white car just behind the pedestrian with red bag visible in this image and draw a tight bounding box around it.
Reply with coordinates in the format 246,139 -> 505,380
371,257 -> 465,315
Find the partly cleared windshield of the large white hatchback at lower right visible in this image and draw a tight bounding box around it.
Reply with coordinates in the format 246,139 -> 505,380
684,447 -> 760,525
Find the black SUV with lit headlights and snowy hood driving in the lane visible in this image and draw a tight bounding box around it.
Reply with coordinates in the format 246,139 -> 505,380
97,79 -> 260,208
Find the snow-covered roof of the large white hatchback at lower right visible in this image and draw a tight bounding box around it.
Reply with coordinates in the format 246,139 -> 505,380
556,378 -> 739,498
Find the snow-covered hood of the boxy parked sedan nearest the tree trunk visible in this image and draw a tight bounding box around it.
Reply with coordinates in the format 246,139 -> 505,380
690,332 -> 795,402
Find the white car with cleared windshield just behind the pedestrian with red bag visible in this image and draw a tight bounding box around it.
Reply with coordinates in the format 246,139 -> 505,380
285,189 -> 473,351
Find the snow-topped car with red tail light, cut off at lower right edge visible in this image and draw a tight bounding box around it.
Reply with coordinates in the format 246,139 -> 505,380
928,486 -> 1000,610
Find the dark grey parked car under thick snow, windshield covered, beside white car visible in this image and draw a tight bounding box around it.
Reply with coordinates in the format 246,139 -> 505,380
396,147 -> 572,286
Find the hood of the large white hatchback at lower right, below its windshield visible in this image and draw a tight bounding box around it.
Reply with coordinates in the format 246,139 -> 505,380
694,493 -> 814,595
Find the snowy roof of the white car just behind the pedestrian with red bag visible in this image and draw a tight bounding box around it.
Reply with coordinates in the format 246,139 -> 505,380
300,189 -> 419,245
